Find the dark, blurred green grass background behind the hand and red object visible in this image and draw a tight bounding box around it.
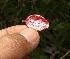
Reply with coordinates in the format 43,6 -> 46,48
0,0 -> 70,59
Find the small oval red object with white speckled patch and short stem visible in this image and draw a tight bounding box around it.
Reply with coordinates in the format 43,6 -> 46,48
22,14 -> 49,31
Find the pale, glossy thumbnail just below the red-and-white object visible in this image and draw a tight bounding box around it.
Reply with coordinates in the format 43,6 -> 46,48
20,28 -> 39,43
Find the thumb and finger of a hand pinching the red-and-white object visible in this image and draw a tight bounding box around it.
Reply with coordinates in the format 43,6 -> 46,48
0,25 -> 39,59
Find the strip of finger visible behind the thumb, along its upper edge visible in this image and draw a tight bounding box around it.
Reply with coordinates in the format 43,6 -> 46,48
0,25 -> 27,37
